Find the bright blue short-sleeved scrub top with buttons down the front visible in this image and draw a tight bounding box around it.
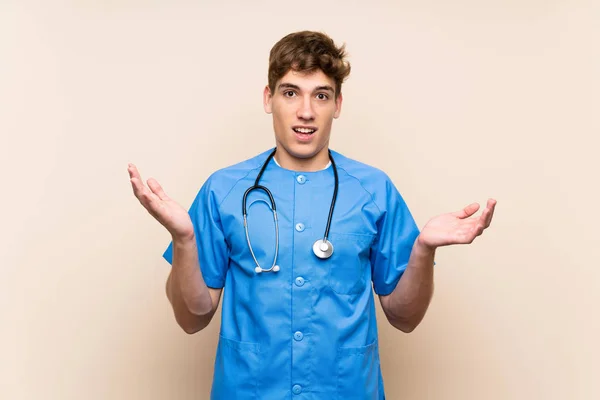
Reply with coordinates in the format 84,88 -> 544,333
164,149 -> 419,400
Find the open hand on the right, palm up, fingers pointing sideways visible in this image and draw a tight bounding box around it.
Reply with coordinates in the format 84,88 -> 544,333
419,199 -> 496,249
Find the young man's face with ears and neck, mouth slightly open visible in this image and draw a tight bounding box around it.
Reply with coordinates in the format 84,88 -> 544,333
264,70 -> 342,168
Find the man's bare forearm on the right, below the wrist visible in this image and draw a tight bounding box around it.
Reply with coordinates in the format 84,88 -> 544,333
385,239 -> 435,332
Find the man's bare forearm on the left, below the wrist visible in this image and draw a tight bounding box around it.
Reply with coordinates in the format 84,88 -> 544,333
167,237 -> 213,333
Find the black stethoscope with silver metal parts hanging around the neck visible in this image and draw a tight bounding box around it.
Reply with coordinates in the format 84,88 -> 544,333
242,148 -> 339,273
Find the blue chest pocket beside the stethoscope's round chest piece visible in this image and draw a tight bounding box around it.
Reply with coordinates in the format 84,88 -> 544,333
327,232 -> 375,294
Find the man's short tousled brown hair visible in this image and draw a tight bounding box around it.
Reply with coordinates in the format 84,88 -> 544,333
269,31 -> 350,97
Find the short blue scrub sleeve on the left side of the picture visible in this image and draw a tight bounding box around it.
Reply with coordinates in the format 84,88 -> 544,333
163,178 -> 229,288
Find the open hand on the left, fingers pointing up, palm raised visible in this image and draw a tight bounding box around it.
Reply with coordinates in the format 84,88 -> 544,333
127,164 -> 194,238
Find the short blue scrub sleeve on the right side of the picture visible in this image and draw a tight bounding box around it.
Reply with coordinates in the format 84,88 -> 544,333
370,180 -> 420,295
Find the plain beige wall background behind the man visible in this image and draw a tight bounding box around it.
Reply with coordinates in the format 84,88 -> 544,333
0,0 -> 600,400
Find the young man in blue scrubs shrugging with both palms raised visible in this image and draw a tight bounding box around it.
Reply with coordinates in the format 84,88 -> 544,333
129,32 -> 496,399
